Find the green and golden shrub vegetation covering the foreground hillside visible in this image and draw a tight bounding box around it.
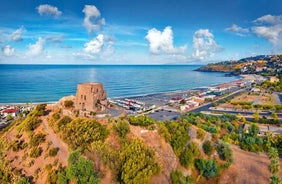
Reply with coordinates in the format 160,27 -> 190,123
0,102 -> 282,183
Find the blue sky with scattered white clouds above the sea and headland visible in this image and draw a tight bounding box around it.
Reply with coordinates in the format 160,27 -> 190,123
0,0 -> 282,64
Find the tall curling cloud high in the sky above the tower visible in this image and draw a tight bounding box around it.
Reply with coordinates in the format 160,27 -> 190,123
82,5 -> 106,33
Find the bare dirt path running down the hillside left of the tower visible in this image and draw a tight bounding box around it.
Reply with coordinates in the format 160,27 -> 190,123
42,116 -> 69,166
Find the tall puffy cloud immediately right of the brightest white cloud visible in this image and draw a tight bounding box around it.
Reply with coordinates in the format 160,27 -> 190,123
193,29 -> 222,60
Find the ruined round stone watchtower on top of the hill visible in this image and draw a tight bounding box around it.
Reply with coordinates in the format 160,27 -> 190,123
75,82 -> 109,112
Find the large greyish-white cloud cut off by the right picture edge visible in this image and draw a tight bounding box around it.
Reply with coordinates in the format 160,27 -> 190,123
252,15 -> 282,45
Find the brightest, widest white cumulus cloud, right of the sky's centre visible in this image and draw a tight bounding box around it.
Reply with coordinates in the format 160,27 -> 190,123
145,26 -> 187,54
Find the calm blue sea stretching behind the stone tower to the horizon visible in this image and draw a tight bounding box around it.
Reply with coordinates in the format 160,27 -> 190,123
0,65 -> 238,103
